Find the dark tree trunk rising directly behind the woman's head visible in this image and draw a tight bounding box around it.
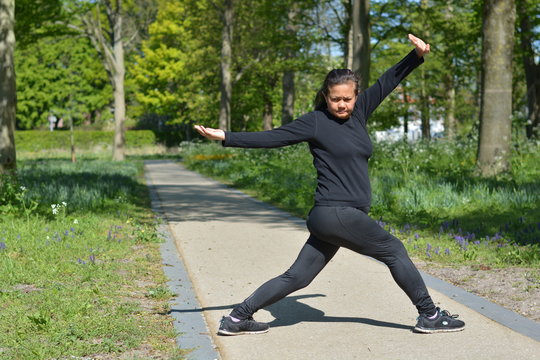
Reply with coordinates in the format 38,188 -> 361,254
352,0 -> 370,90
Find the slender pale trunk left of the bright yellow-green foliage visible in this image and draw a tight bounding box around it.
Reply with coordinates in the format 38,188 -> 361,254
111,1 -> 126,161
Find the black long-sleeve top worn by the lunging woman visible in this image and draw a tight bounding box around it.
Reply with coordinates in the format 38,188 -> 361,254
222,50 -> 424,208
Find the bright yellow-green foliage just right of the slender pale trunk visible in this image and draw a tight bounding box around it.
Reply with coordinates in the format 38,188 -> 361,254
132,0 -> 219,128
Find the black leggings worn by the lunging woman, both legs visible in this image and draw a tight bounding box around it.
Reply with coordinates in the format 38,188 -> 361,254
231,206 -> 435,319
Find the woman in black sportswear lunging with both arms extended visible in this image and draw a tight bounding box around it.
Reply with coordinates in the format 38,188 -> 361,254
195,34 -> 465,335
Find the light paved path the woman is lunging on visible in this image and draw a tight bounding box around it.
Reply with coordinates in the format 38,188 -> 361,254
146,161 -> 540,360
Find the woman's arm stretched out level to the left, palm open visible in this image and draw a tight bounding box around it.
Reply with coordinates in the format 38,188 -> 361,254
195,113 -> 316,148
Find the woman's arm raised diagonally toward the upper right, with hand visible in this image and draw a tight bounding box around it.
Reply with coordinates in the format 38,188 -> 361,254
357,34 -> 430,118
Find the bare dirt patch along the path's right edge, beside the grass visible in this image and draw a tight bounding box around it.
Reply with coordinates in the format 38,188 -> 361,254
415,260 -> 540,322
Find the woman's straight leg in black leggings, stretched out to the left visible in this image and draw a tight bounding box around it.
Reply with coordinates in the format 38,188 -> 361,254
231,235 -> 339,320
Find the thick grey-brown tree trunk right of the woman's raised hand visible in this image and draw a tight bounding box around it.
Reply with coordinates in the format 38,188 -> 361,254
476,0 -> 516,176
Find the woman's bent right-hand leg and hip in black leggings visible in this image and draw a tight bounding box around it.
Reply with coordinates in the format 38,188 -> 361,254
308,207 -> 436,315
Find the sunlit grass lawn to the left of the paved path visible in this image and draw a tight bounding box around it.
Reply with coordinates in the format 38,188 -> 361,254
0,157 -> 185,359
